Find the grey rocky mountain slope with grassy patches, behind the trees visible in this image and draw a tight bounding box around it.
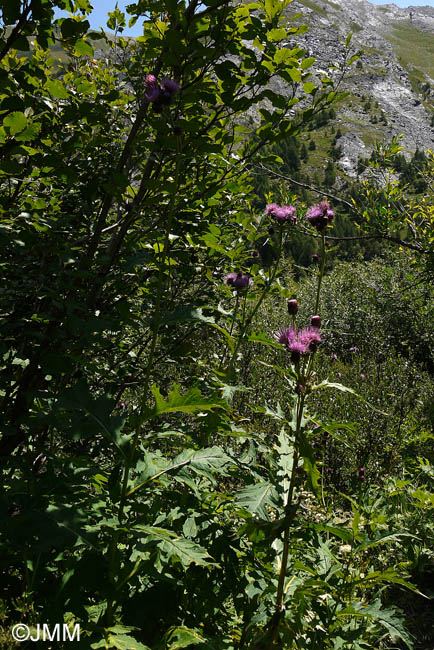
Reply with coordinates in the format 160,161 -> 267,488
287,0 -> 434,175
